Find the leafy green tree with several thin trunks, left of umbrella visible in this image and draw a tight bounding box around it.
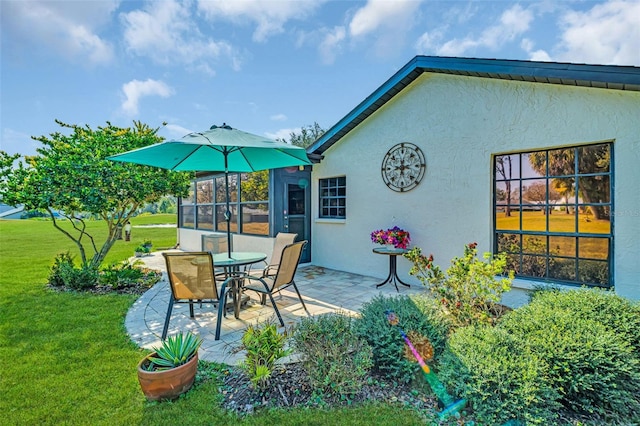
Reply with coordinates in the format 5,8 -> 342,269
0,120 -> 192,268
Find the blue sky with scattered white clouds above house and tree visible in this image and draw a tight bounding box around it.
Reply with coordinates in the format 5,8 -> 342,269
0,0 -> 640,155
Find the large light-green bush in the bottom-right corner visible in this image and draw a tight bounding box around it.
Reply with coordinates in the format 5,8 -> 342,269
499,290 -> 640,420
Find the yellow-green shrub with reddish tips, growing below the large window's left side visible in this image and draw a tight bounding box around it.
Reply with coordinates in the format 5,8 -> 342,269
404,243 -> 514,326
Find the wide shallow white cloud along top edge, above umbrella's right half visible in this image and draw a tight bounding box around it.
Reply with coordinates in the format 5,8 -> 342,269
198,0 -> 324,42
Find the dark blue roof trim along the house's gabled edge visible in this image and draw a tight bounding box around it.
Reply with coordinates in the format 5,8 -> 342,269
307,56 -> 640,155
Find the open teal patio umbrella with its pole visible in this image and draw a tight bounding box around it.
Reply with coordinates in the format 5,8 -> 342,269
109,124 -> 311,257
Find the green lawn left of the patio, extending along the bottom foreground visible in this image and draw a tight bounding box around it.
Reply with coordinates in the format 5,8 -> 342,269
0,215 -> 424,425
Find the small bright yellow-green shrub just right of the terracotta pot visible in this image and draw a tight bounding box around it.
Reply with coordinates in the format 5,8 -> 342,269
241,321 -> 291,389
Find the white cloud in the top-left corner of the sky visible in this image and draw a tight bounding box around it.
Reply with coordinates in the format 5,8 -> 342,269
0,0 -> 119,64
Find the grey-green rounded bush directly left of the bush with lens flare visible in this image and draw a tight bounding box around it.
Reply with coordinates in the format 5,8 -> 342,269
293,313 -> 372,396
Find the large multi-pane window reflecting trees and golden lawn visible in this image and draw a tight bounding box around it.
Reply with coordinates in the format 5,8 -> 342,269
494,143 -> 613,287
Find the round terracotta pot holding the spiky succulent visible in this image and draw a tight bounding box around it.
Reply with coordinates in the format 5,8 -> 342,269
138,352 -> 198,401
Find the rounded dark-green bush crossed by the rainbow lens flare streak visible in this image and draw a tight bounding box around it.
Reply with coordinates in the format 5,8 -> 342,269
354,295 -> 449,382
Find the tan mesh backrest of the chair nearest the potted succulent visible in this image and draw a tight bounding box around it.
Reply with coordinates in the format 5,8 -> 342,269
162,252 -> 218,301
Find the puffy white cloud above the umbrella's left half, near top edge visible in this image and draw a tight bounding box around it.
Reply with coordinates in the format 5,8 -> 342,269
121,0 -> 238,68
